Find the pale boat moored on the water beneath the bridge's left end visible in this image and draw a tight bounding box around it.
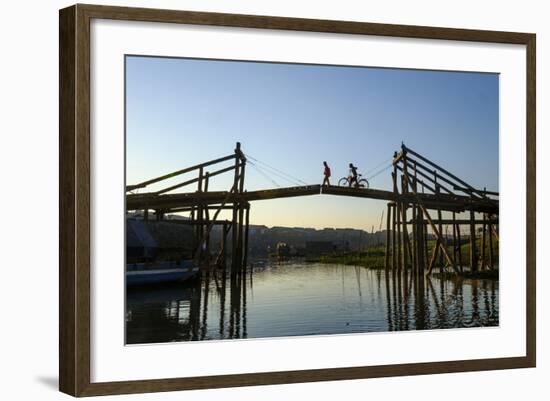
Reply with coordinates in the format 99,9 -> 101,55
126,260 -> 199,286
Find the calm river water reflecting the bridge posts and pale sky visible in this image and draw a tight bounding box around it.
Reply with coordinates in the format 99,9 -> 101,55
126,261 -> 499,344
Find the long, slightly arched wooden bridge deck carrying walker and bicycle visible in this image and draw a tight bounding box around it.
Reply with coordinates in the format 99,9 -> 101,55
126,185 -> 498,213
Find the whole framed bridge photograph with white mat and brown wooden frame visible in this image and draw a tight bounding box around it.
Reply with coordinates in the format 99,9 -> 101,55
59,5 -> 536,396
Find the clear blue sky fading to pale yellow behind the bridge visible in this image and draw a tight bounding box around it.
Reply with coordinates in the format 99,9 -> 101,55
126,56 -> 499,231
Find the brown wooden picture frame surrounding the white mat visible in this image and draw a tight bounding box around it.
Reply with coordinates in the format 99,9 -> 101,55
59,5 -> 536,396
